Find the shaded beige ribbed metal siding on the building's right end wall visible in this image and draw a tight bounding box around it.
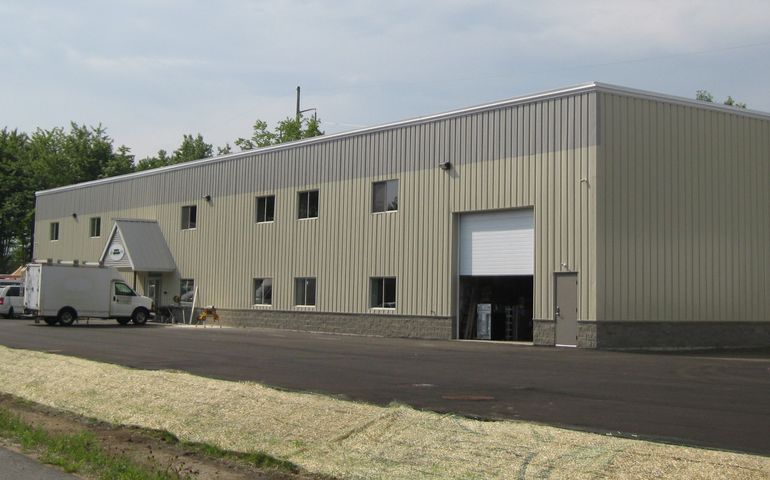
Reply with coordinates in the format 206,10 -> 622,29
597,93 -> 770,321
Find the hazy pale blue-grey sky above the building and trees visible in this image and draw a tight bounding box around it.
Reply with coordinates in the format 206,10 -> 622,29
0,0 -> 770,158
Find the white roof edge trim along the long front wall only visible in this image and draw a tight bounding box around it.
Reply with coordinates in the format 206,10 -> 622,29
35,82 -> 596,196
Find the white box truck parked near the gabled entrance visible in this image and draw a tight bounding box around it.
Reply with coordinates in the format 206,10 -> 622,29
24,263 -> 153,326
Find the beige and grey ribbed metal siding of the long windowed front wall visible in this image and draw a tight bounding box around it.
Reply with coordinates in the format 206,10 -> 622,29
35,92 -> 596,319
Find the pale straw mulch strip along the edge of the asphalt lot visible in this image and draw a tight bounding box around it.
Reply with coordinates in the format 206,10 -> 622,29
0,347 -> 770,479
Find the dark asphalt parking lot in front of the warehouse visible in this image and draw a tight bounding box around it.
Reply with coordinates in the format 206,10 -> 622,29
0,319 -> 770,455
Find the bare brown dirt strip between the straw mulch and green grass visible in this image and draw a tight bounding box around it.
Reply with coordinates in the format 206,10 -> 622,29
0,394 -> 330,480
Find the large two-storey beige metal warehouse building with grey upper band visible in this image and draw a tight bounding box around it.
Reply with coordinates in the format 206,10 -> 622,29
34,83 -> 770,348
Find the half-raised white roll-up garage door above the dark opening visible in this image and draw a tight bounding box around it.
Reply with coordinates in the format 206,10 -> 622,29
460,208 -> 535,275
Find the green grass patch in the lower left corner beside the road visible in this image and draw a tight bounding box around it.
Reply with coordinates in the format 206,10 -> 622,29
0,408 -> 188,480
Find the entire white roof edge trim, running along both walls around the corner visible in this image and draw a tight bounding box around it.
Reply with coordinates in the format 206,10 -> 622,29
35,81 -> 770,197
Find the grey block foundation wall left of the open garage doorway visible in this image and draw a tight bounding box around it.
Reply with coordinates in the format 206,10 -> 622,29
212,309 -> 452,340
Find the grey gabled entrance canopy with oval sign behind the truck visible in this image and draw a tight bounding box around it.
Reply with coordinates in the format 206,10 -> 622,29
99,219 -> 176,272
